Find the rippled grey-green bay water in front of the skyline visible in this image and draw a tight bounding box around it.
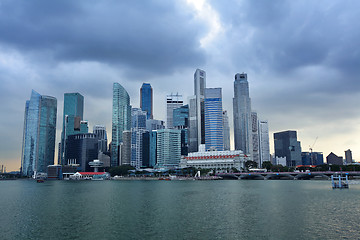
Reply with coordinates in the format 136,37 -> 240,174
0,180 -> 360,239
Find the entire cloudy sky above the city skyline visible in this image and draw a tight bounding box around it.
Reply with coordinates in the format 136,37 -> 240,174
0,0 -> 360,171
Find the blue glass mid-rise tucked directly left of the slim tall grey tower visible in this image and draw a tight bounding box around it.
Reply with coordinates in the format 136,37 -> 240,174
173,105 -> 189,156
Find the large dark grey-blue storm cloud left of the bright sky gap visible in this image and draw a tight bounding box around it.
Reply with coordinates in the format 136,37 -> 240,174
0,0 -> 204,73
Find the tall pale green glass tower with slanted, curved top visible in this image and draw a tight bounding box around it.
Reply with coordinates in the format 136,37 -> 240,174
111,83 -> 131,166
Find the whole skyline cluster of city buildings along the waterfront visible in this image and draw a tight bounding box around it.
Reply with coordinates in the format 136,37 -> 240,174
21,69 -> 352,176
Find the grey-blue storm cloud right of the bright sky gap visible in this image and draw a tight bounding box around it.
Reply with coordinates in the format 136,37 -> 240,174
212,0 -> 360,91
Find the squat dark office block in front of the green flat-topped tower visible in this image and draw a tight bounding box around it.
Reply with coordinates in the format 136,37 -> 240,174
66,133 -> 98,172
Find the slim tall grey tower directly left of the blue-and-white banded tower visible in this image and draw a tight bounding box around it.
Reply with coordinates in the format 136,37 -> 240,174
189,69 -> 206,152
